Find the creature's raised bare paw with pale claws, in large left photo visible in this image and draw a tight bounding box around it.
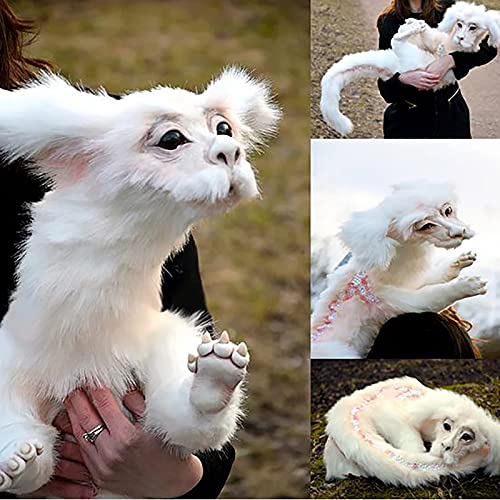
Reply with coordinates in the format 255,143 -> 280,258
188,332 -> 250,412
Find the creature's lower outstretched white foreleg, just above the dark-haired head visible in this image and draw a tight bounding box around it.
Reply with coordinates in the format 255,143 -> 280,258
377,276 -> 486,313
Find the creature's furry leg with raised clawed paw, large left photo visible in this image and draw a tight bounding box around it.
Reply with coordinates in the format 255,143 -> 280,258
145,312 -> 249,458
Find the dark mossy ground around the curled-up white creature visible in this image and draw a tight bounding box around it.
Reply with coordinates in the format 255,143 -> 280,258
311,360 -> 500,498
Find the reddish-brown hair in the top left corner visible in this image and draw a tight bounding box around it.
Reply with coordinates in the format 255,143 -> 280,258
0,0 -> 52,90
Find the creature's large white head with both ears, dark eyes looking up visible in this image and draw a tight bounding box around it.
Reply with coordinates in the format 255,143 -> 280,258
0,68 -> 280,218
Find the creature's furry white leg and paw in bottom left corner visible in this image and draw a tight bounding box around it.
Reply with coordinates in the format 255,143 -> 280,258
0,396 -> 57,495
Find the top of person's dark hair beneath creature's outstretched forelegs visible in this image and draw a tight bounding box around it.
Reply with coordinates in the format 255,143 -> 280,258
368,311 -> 480,359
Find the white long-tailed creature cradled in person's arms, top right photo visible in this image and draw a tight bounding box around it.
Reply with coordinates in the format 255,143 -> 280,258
320,2 -> 500,135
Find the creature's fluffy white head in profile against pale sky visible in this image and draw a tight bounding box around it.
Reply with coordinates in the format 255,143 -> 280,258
339,181 -> 474,270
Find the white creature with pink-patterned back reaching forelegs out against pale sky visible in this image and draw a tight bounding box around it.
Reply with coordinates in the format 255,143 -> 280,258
311,181 -> 486,358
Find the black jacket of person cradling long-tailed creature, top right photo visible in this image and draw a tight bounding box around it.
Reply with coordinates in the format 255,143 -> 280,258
378,1 -> 497,139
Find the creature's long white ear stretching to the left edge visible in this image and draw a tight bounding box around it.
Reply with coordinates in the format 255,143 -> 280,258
0,73 -> 115,182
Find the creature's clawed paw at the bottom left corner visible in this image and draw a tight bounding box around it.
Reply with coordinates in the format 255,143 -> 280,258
0,439 -> 53,494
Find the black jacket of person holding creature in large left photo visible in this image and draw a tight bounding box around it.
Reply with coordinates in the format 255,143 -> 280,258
0,161 -> 235,498
